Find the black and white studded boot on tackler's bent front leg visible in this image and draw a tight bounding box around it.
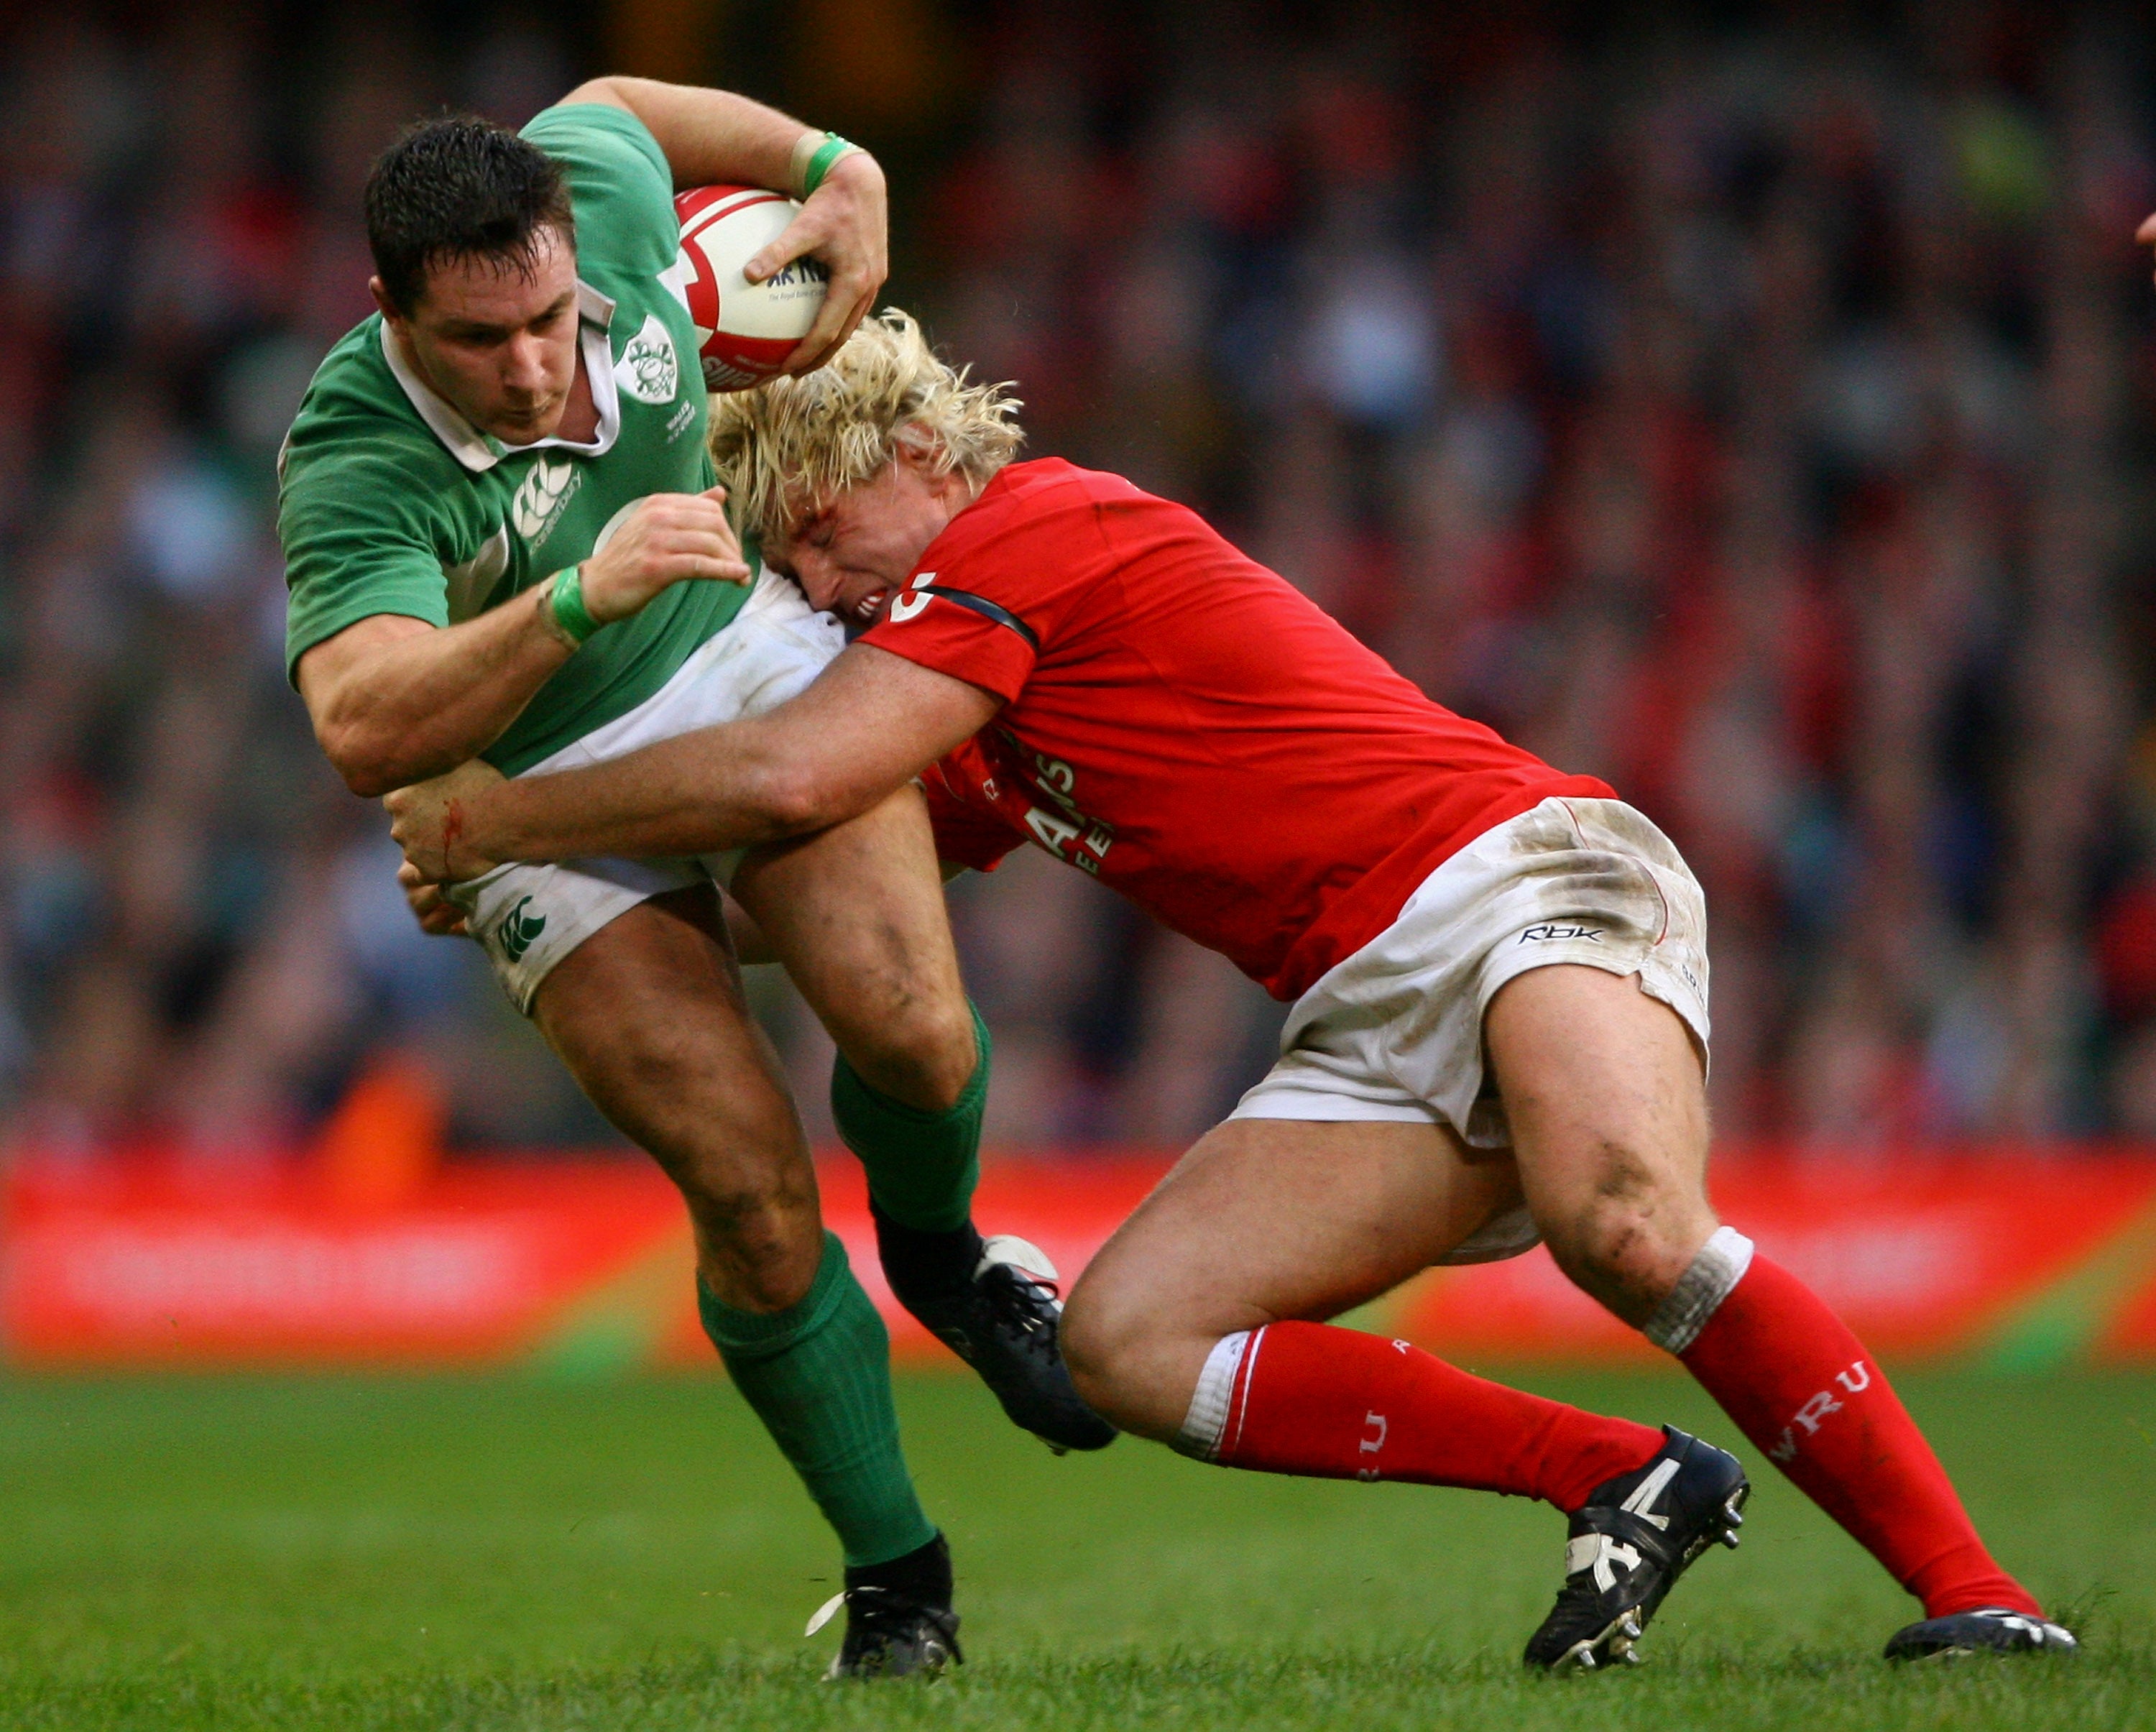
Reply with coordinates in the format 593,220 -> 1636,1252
1526,1426 -> 1751,1672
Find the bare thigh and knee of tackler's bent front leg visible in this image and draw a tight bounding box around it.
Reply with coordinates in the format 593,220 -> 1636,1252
1065,1120 -> 1520,1424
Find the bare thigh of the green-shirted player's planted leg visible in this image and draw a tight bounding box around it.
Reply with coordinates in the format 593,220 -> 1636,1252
533,885 -> 815,1215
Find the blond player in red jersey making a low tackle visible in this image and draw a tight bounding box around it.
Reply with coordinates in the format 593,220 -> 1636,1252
392,313 -> 2074,1667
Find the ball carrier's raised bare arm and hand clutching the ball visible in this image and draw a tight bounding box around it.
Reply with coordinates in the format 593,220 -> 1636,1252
563,75 -> 890,373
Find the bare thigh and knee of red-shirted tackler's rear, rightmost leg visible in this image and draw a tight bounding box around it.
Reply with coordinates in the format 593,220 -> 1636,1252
1483,964 -> 1714,1309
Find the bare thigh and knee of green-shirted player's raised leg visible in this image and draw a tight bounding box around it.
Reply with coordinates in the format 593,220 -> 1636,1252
731,787 -> 977,1111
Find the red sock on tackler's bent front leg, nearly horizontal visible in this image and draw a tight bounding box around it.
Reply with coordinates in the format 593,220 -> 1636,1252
1190,1322 -> 1662,1514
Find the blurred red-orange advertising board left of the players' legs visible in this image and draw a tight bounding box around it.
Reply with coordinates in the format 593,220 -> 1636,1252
0,1163 -> 681,1363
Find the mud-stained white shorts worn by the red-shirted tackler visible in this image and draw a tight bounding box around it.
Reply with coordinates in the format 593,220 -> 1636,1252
1229,796 -> 1710,1264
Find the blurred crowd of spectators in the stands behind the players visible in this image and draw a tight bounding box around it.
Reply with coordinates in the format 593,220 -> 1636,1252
0,0 -> 2156,1165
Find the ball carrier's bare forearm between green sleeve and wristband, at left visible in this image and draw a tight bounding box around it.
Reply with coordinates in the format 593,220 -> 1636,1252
298,589 -> 569,796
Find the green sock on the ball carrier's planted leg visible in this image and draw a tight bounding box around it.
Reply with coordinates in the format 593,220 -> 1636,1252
696,1232 -> 936,1568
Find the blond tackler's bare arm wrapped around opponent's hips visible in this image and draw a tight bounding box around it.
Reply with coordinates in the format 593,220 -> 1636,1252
405,642 -> 1000,876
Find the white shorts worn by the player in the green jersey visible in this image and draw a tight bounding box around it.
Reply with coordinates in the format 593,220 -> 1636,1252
448,571 -> 845,1016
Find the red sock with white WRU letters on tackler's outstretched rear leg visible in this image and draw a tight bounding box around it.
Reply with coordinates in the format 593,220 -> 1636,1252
1684,1253 -> 2040,1618
